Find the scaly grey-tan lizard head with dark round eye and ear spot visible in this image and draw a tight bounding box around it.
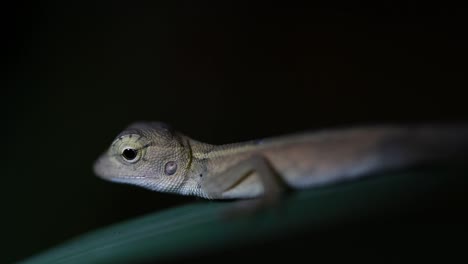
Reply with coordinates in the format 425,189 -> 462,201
94,122 -> 192,192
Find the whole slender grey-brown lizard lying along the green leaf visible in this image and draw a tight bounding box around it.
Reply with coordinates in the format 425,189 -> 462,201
93,122 -> 468,201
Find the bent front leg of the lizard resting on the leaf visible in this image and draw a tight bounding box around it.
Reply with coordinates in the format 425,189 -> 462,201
202,155 -> 289,204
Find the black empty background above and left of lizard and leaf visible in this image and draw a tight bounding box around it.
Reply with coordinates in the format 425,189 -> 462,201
1,1 -> 468,263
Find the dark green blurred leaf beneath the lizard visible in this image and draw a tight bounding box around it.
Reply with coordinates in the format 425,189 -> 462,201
24,168 -> 467,264
